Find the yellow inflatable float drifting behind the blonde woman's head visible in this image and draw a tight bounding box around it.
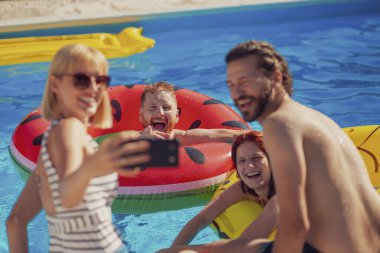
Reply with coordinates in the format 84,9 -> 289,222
0,27 -> 155,66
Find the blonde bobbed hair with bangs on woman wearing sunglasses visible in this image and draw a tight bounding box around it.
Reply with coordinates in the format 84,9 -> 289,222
41,44 -> 112,128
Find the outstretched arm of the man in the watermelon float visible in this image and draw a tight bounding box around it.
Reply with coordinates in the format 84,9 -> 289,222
172,128 -> 251,145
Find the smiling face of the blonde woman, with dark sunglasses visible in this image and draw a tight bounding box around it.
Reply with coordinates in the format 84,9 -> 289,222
51,61 -> 109,123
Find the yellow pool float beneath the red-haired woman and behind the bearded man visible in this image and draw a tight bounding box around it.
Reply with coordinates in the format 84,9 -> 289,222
211,125 -> 380,239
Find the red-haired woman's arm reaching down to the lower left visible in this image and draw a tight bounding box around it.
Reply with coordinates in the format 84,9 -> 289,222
172,183 -> 245,247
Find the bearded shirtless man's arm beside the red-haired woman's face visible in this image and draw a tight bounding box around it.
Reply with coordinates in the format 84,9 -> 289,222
264,120 -> 309,253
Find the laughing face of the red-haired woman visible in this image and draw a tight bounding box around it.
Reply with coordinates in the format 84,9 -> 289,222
236,141 -> 271,191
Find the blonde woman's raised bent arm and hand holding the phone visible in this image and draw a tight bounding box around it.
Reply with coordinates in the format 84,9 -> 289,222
49,118 -> 149,208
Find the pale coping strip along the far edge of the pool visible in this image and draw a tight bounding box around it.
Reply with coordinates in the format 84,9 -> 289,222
0,0 -> 344,33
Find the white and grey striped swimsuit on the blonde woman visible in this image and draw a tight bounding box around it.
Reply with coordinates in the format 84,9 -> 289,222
41,121 -> 125,252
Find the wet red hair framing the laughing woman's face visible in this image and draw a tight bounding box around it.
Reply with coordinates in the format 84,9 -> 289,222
231,131 -> 276,200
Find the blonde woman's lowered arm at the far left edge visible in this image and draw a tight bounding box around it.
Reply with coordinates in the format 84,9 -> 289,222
7,172 -> 42,252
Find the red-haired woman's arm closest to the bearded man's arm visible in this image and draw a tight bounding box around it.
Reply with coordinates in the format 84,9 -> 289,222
239,195 -> 280,241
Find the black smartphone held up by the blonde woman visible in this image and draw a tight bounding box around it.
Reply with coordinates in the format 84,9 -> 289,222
121,139 -> 179,170
